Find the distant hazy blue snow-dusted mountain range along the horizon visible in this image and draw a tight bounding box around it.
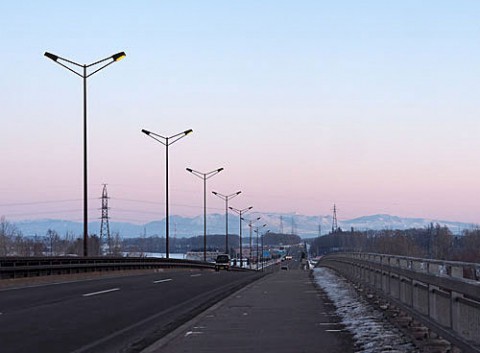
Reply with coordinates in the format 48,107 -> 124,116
14,213 -> 475,238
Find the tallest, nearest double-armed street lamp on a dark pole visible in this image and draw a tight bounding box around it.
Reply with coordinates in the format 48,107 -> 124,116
44,51 -> 126,256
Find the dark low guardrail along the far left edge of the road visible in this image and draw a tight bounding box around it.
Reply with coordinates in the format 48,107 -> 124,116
0,256 -> 225,280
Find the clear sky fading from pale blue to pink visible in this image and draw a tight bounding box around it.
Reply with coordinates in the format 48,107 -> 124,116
0,0 -> 480,223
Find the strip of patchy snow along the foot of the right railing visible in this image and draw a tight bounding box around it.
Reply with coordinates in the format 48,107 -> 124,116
313,267 -> 418,353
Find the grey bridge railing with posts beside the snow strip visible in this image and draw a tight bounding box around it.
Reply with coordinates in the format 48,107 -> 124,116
319,253 -> 480,353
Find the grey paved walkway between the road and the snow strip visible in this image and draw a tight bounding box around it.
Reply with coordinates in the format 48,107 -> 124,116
142,263 -> 354,353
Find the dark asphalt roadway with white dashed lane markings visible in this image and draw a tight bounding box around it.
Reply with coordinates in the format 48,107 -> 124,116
0,270 -> 259,353
